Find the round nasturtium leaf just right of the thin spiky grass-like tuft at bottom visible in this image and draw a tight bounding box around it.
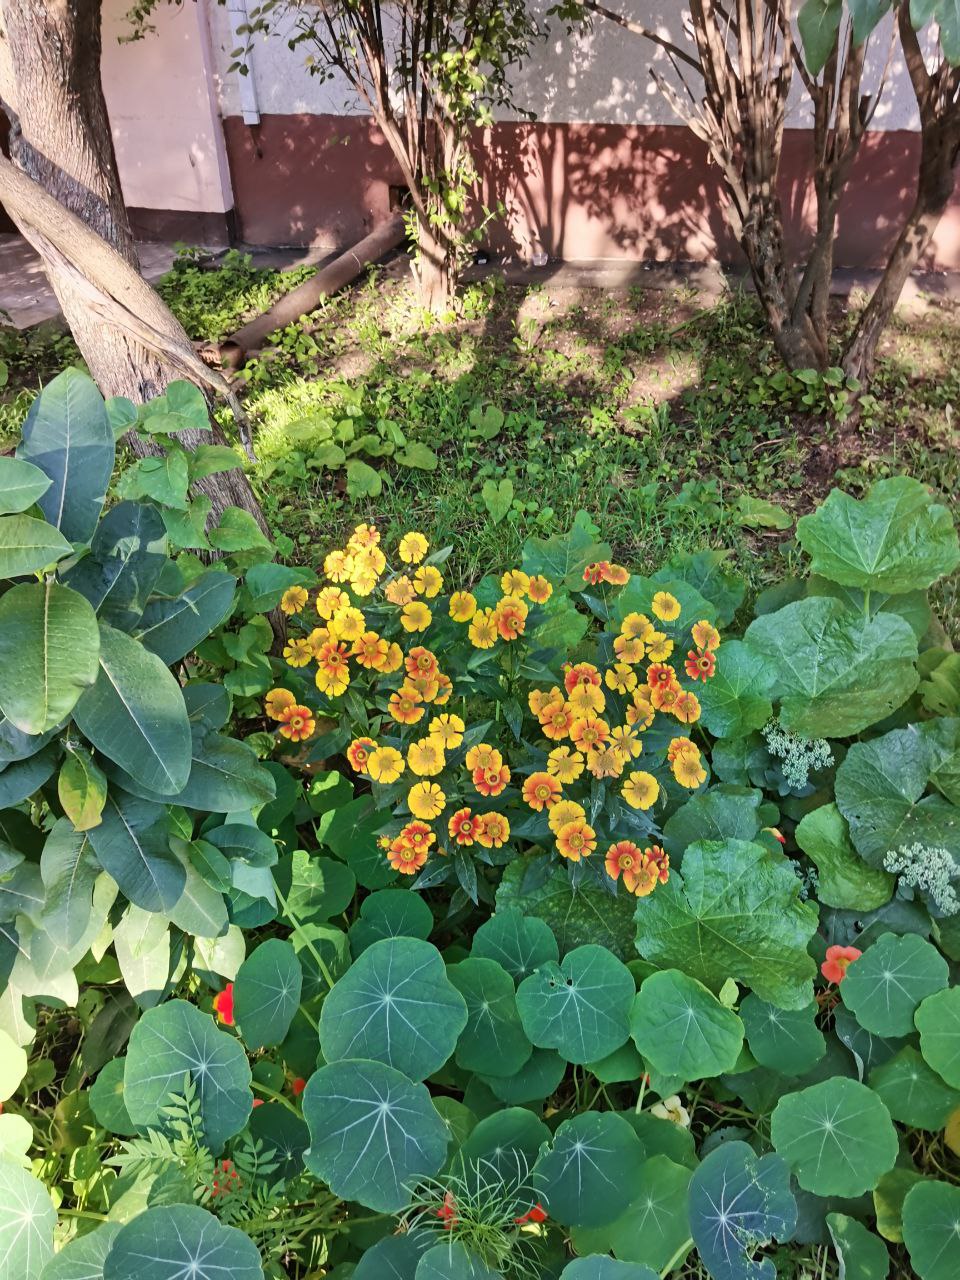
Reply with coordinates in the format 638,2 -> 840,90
534,1111 -> 644,1226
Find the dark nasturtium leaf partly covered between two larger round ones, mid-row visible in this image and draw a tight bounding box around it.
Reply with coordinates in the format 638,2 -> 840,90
447,956 -> 534,1075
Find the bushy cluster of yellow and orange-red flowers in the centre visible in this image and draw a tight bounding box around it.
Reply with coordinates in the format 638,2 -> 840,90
259,525 -> 721,897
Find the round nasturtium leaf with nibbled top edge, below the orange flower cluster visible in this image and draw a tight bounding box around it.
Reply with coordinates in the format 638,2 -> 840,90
517,945 -> 636,1062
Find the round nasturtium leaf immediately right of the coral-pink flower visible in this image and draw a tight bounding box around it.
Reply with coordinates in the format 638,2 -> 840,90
840,933 -> 950,1036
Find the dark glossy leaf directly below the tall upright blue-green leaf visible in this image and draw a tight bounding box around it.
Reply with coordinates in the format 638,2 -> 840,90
63,502 -> 166,631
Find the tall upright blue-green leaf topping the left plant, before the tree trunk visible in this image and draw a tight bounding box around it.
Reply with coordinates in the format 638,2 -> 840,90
17,369 -> 116,543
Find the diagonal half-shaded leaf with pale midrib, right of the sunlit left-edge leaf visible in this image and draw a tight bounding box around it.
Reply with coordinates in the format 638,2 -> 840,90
73,623 -> 191,796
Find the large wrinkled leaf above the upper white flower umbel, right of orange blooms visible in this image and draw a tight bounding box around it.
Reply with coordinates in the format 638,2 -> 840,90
745,596 -> 919,737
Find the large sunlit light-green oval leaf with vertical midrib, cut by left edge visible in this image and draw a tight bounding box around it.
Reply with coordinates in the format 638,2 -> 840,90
0,582 -> 100,733
